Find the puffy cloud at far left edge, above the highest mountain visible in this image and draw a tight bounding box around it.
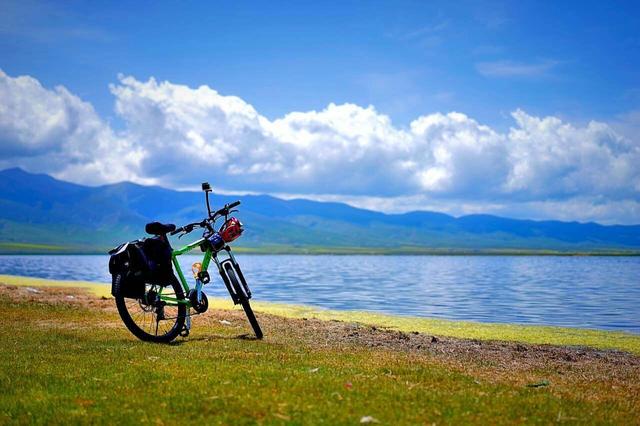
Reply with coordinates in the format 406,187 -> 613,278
0,70 -> 140,183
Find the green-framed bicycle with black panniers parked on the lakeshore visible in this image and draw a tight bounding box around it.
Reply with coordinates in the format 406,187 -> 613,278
109,182 -> 263,343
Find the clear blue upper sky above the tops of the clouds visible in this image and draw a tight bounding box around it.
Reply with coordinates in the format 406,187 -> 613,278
5,1 -> 640,125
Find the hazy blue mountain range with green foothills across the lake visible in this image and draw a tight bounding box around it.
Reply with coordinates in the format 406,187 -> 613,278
0,168 -> 640,253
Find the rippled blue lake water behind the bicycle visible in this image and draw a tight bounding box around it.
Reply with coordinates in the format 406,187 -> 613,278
0,255 -> 640,333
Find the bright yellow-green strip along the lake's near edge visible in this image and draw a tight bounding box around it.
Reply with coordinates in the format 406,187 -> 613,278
0,275 -> 640,355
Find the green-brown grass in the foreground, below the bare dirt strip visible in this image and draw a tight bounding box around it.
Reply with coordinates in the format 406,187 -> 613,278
0,277 -> 638,425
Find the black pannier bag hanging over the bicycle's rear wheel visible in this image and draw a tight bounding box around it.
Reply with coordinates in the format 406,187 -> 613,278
109,237 -> 175,299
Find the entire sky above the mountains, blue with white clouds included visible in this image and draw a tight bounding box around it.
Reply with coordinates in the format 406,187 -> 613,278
0,0 -> 640,224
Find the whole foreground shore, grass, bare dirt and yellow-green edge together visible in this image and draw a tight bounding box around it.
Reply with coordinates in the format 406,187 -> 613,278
0,276 -> 640,425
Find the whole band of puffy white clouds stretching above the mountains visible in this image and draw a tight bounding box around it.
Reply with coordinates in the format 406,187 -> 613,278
0,73 -> 640,222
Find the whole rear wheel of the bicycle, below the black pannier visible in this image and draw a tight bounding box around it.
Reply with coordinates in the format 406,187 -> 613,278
116,280 -> 187,343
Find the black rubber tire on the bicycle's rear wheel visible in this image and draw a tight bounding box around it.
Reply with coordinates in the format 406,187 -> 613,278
115,280 -> 187,343
